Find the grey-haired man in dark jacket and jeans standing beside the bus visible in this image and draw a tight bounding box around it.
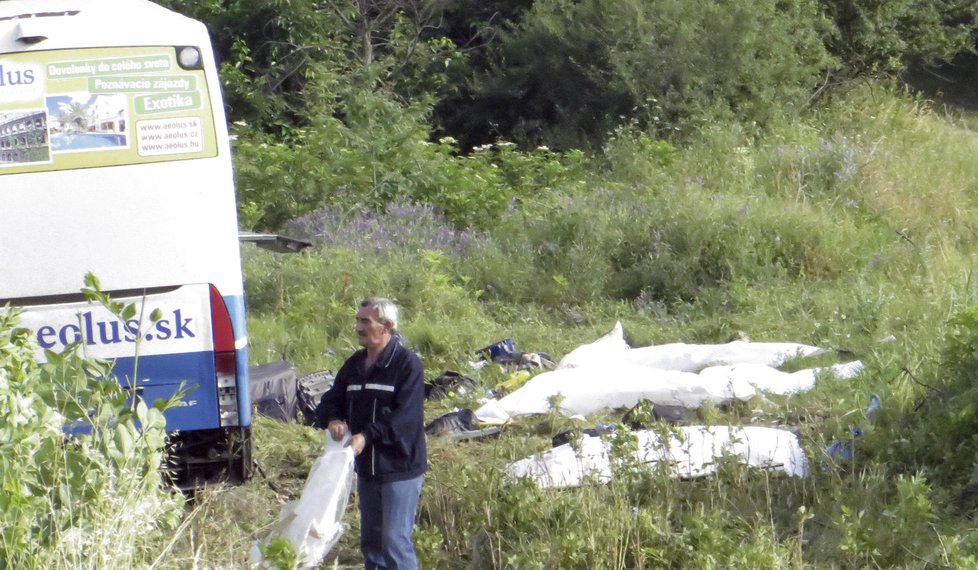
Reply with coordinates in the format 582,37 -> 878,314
316,297 -> 428,570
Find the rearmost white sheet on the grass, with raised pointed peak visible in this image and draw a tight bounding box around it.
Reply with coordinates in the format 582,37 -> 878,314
556,321 -> 826,372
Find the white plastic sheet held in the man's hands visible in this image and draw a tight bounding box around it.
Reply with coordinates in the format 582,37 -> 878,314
251,432 -> 354,569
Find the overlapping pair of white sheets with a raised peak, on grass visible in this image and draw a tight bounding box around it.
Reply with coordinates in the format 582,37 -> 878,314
475,323 -> 863,423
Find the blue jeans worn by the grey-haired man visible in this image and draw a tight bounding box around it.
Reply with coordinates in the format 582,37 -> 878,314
357,475 -> 424,570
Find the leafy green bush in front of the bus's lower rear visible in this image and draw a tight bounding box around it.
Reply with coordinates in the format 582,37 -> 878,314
0,310 -> 182,568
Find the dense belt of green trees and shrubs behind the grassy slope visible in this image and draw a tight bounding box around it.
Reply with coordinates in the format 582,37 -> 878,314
154,0 -> 978,229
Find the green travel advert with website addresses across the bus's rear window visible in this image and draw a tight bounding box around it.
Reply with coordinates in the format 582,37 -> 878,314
0,46 -> 217,174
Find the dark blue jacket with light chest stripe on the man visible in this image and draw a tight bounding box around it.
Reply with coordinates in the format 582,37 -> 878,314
316,335 -> 428,482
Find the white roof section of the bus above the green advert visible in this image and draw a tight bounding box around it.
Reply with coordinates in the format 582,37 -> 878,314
0,0 -> 206,53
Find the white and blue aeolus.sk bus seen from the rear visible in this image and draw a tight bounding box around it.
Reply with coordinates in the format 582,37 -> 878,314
0,0 -> 252,487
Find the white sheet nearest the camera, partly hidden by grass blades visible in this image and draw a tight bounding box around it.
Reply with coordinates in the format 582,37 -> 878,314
505,426 -> 808,489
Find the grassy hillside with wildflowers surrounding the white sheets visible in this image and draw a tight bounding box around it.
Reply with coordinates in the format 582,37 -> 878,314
9,85 -> 978,569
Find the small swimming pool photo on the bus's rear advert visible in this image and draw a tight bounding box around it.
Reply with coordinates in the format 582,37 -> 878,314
45,92 -> 129,154
